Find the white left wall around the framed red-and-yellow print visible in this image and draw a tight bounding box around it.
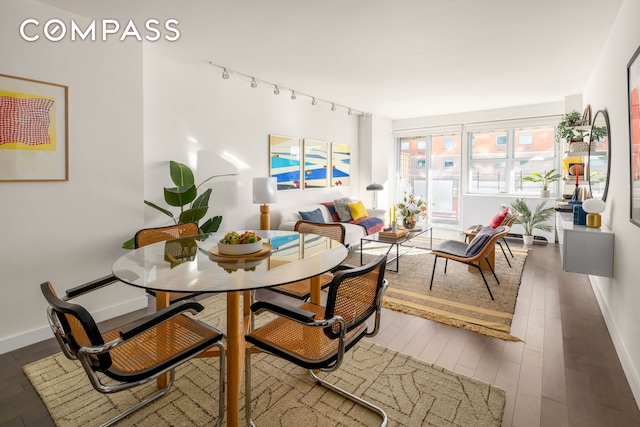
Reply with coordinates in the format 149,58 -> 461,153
0,0 -> 146,353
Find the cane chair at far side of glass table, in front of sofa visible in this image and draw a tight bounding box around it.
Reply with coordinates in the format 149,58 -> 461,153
269,221 -> 345,301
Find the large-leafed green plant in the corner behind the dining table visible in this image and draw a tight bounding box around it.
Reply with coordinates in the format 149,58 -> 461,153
122,160 -> 236,249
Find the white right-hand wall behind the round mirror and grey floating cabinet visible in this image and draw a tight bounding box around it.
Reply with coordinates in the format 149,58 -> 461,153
583,0 -> 640,402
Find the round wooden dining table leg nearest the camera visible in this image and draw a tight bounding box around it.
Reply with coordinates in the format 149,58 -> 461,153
227,292 -> 245,427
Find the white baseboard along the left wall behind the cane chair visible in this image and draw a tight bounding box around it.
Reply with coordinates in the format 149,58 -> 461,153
0,296 -> 149,354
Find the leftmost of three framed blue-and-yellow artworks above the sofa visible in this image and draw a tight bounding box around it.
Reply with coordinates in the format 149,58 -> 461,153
269,135 -> 302,190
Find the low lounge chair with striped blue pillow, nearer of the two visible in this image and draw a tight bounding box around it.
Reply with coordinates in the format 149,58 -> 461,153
429,226 -> 511,300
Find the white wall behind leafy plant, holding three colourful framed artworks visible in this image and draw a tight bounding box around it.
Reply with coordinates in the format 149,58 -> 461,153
144,52 -> 368,234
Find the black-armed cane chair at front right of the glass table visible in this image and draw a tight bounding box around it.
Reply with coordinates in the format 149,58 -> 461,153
245,255 -> 388,426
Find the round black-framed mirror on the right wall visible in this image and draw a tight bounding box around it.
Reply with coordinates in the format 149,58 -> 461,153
588,110 -> 611,201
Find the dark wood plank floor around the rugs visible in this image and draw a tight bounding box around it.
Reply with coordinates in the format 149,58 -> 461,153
0,236 -> 640,427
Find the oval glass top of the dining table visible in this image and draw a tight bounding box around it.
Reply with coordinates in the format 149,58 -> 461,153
112,230 -> 347,292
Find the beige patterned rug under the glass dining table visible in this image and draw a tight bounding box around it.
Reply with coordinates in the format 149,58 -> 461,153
24,296 -> 505,427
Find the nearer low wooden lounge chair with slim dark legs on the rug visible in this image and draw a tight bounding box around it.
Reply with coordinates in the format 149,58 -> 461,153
429,226 -> 511,300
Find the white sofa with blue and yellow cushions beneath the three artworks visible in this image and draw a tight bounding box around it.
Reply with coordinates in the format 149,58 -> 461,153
271,202 -> 386,248
